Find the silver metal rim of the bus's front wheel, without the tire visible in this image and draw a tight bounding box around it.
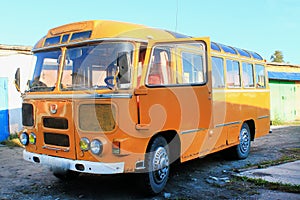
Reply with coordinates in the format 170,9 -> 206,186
152,147 -> 169,183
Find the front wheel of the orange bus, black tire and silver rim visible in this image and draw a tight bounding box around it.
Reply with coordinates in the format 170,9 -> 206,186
145,136 -> 170,194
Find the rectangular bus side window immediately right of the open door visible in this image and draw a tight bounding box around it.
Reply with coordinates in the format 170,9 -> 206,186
212,57 -> 225,88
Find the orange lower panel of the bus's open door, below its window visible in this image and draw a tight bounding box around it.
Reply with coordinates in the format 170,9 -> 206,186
139,85 -> 214,161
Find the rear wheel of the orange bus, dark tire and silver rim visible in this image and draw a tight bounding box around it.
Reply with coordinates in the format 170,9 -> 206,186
224,123 -> 251,160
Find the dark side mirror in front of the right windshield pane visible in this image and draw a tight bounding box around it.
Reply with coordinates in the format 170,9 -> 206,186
117,52 -> 131,84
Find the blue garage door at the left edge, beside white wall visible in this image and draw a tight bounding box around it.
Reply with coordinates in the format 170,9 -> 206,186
0,78 -> 9,142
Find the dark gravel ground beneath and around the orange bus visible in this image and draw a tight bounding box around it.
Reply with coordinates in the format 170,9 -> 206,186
0,126 -> 300,200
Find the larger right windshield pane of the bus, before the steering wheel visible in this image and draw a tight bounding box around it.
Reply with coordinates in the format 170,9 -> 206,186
61,42 -> 134,91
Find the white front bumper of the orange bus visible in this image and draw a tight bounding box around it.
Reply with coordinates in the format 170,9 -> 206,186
23,150 -> 125,174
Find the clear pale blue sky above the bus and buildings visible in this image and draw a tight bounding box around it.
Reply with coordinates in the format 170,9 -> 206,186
0,0 -> 300,64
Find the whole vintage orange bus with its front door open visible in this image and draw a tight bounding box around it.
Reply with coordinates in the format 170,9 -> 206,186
16,20 -> 270,194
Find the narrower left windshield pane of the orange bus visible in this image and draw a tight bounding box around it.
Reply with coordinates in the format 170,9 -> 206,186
29,50 -> 61,92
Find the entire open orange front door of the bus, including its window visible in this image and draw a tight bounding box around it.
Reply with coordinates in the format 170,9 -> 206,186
135,38 -> 211,161
